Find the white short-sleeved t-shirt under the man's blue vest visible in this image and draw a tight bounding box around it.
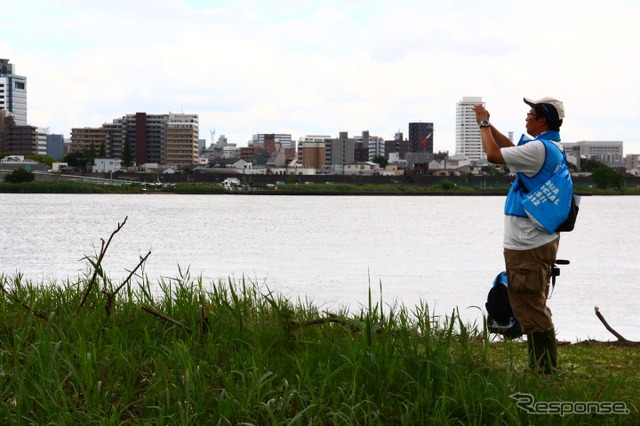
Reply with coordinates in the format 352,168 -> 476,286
500,141 -> 562,250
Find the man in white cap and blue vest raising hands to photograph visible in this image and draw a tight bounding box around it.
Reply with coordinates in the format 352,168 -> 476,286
475,97 -> 566,373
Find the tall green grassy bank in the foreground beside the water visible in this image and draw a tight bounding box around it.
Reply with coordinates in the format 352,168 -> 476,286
0,220 -> 640,425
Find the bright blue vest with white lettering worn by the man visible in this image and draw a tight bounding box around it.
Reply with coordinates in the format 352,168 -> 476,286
504,131 -> 573,234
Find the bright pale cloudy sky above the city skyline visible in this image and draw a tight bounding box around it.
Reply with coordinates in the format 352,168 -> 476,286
5,0 -> 640,155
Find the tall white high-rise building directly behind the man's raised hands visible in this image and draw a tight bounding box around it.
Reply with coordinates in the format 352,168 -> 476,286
456,96 -> 486,160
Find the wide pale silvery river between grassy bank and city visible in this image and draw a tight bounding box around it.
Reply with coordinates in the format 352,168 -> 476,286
0,194 -> 640,341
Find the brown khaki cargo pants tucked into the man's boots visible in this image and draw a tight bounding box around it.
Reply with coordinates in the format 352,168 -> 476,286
504,237 -> 560,334
